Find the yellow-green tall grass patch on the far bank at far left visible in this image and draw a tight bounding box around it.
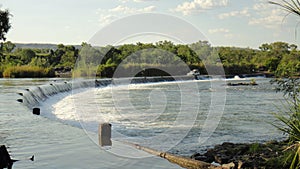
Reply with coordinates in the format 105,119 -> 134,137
3,65 -> 55,78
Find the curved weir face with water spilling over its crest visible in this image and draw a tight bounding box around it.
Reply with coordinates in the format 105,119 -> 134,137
18,76 -> 195,109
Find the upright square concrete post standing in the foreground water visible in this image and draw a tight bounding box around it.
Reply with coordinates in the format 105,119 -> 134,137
98,123 -> 112,147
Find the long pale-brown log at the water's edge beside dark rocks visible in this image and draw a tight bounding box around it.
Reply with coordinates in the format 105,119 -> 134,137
128,143 -> 227,169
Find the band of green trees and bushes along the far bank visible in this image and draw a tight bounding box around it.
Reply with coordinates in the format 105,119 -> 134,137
0,41 -> 300,77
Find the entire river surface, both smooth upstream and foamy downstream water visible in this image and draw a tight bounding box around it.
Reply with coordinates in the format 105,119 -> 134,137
0,78 -> 284,168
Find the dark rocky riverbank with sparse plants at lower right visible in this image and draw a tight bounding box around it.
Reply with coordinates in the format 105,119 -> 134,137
190,141 -> 289,169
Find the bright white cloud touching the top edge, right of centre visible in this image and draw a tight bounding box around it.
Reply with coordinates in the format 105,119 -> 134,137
174,0 -> 228,15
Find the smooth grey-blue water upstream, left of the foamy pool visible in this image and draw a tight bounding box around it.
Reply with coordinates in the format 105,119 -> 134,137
0,79 -> 179,169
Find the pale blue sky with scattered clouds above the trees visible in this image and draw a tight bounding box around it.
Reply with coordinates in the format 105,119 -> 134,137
0,0 -> 300,48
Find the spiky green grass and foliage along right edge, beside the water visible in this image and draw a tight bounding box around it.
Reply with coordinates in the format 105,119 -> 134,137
272,78 -> 300,169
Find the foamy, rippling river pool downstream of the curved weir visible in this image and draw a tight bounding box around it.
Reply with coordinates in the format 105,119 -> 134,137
38,78 -> 282,156
